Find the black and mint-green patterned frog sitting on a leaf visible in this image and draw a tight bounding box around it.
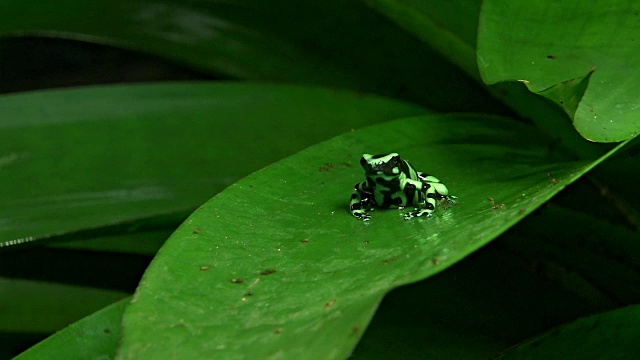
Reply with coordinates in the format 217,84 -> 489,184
350,152 -> 458,221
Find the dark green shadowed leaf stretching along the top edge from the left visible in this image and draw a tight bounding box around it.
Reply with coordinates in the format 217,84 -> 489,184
0,0 -> 504,113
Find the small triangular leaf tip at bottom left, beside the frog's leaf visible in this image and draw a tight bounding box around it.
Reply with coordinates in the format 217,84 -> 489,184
15,298 -> 130,360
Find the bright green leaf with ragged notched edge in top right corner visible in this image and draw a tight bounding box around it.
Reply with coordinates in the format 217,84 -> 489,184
478,0 -> 640,142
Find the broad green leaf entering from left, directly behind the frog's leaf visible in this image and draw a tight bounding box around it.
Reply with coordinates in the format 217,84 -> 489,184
0,83 -> 426,248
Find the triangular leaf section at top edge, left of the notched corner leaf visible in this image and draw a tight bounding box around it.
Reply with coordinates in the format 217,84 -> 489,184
365,0 -> 482,80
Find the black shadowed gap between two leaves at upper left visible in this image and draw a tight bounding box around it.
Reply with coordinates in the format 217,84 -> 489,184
0,37 -> 224,94
